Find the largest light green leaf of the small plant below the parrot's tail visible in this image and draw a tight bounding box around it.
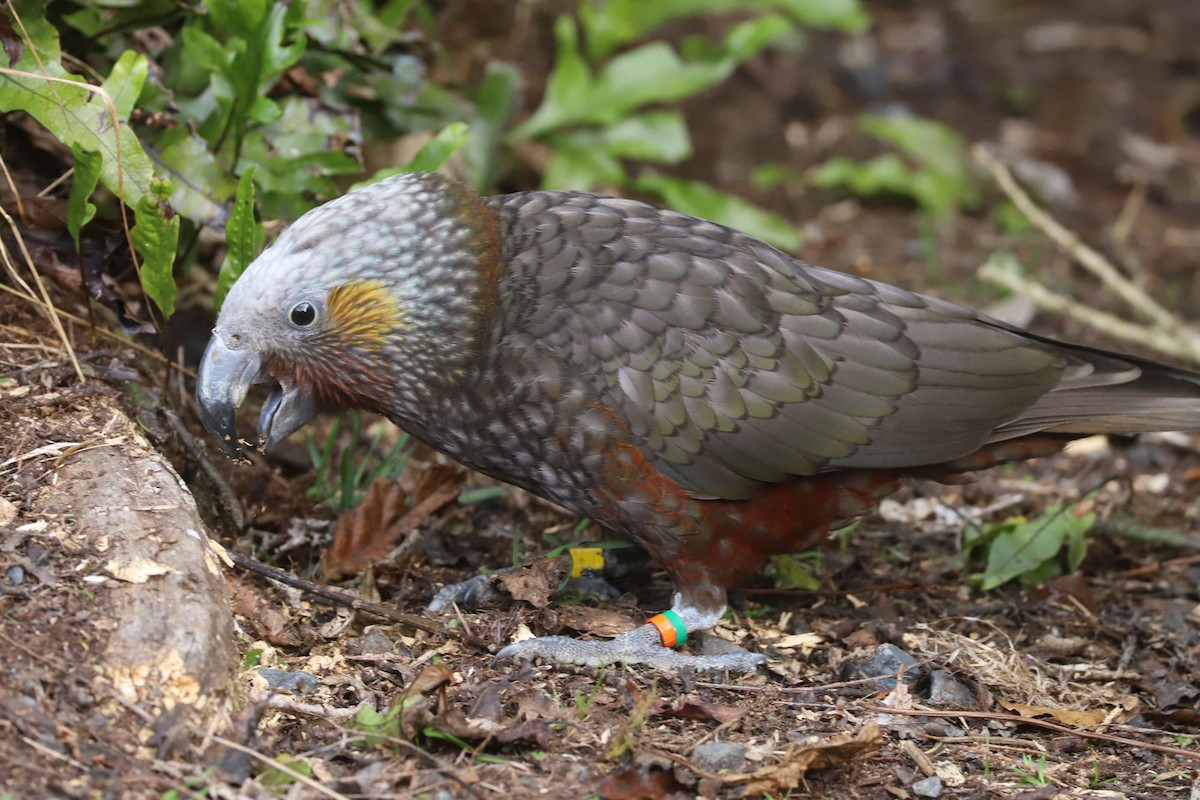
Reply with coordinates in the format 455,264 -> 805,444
980,506 -> 1096,591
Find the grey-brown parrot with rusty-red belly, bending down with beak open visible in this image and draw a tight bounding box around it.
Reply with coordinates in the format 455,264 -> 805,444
196,173 -> 1200,672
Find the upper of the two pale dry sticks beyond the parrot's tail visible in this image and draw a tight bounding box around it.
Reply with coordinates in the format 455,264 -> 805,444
972,144 -> 1193,338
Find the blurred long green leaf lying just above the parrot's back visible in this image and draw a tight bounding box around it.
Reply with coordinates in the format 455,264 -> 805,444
634,173 -> 804,251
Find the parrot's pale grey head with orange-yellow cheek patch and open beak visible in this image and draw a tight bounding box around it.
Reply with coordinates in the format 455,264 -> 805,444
196,174 -> 499,458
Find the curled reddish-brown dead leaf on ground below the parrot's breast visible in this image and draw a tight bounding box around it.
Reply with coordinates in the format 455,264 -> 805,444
320,464 -> 462,581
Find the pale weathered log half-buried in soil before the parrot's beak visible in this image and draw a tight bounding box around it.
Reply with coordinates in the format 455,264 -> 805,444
36,409 -> 236,709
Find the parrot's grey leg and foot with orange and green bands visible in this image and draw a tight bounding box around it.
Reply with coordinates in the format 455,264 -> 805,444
496,585 -> 767,672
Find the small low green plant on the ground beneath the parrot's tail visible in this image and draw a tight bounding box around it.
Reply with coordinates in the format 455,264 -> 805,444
965,506 -> 1096,591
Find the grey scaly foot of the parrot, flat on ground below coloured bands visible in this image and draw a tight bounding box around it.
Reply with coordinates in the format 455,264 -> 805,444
493,625 -> 767,673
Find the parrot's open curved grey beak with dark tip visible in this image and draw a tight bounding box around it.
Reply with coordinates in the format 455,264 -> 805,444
196,336 -> 320,461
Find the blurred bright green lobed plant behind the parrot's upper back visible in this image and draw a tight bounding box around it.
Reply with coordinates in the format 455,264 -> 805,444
508,0 -> 866,248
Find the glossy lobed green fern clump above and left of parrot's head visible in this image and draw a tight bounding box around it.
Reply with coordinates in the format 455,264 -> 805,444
0,0 -> 469,317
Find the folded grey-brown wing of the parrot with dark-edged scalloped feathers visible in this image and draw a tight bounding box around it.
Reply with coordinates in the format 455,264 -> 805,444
493,192 -> 1090,499
